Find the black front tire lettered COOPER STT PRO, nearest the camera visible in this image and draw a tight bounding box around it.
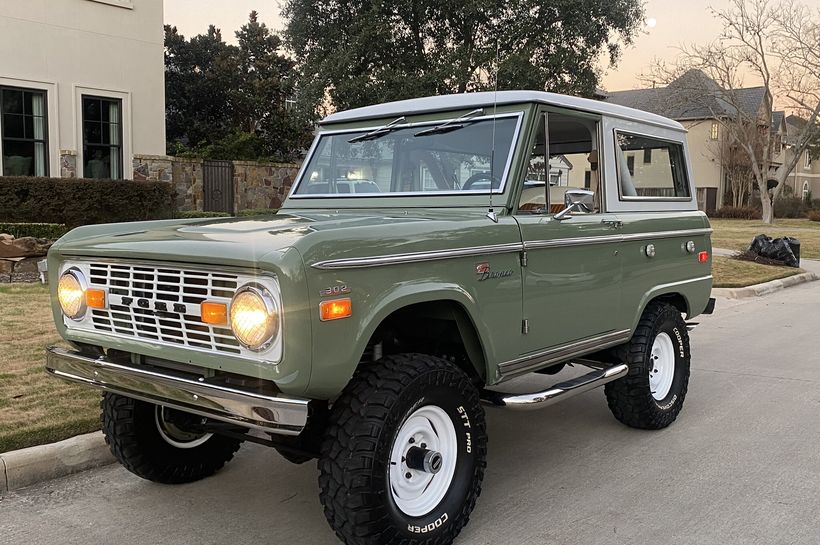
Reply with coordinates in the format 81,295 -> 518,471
319,354 -> 487,545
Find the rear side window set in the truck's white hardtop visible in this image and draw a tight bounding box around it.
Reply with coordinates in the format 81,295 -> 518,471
615,131 -> 691,200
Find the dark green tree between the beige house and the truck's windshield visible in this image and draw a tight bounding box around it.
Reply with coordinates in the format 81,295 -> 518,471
165,11 -> 311,160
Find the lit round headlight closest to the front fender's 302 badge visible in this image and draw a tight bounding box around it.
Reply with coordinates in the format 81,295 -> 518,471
230,285 -> 279,350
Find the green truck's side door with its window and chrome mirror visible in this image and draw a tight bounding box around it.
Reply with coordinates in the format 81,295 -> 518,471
501,107 -> 624,376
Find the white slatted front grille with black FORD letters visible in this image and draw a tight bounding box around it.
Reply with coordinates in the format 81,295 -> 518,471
88,262 -> 244,354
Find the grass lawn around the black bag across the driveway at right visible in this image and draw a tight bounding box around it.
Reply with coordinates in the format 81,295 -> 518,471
709,219 -> 820,259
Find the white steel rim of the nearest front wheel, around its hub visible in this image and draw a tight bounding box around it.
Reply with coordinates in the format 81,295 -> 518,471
389,405 -> 458,517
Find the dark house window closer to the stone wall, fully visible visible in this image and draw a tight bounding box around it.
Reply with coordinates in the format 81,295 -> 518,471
83,95 -> 122,180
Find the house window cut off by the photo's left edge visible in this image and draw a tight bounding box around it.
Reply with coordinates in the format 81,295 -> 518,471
0,87 -> 48,176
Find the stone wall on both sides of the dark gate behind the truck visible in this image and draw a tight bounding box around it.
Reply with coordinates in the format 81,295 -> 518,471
134,155 -> 299,212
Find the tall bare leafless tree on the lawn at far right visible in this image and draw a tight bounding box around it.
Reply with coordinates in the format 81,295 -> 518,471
648,0 -> 820,223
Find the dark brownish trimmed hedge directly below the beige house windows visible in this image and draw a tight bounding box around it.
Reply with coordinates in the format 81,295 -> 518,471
0,176 -> 176,228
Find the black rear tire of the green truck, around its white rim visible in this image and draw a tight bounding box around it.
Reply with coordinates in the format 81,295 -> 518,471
604,302 -> 691,430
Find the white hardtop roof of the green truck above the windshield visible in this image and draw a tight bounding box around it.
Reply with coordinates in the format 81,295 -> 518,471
321,91 -> 686,131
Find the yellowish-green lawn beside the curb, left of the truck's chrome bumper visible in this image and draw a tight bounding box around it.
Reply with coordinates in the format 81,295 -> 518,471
0,284 -> 100,452
